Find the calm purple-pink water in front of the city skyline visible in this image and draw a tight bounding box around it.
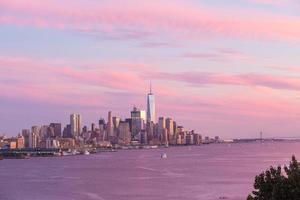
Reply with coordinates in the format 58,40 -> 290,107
0,142 -> 300,200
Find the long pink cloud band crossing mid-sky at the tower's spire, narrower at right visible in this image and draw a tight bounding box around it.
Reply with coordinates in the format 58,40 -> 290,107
0,54 -> 300,110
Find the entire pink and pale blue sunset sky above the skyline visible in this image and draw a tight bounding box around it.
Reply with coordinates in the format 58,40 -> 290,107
0,0 -> 300,138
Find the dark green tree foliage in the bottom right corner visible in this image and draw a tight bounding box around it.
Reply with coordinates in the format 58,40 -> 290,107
247,156 -> 300,200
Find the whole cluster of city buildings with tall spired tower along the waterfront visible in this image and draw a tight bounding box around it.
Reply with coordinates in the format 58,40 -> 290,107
0,86 -> 219,149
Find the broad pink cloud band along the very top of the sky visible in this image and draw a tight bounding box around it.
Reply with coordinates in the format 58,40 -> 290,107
0,0 -> 300,41
